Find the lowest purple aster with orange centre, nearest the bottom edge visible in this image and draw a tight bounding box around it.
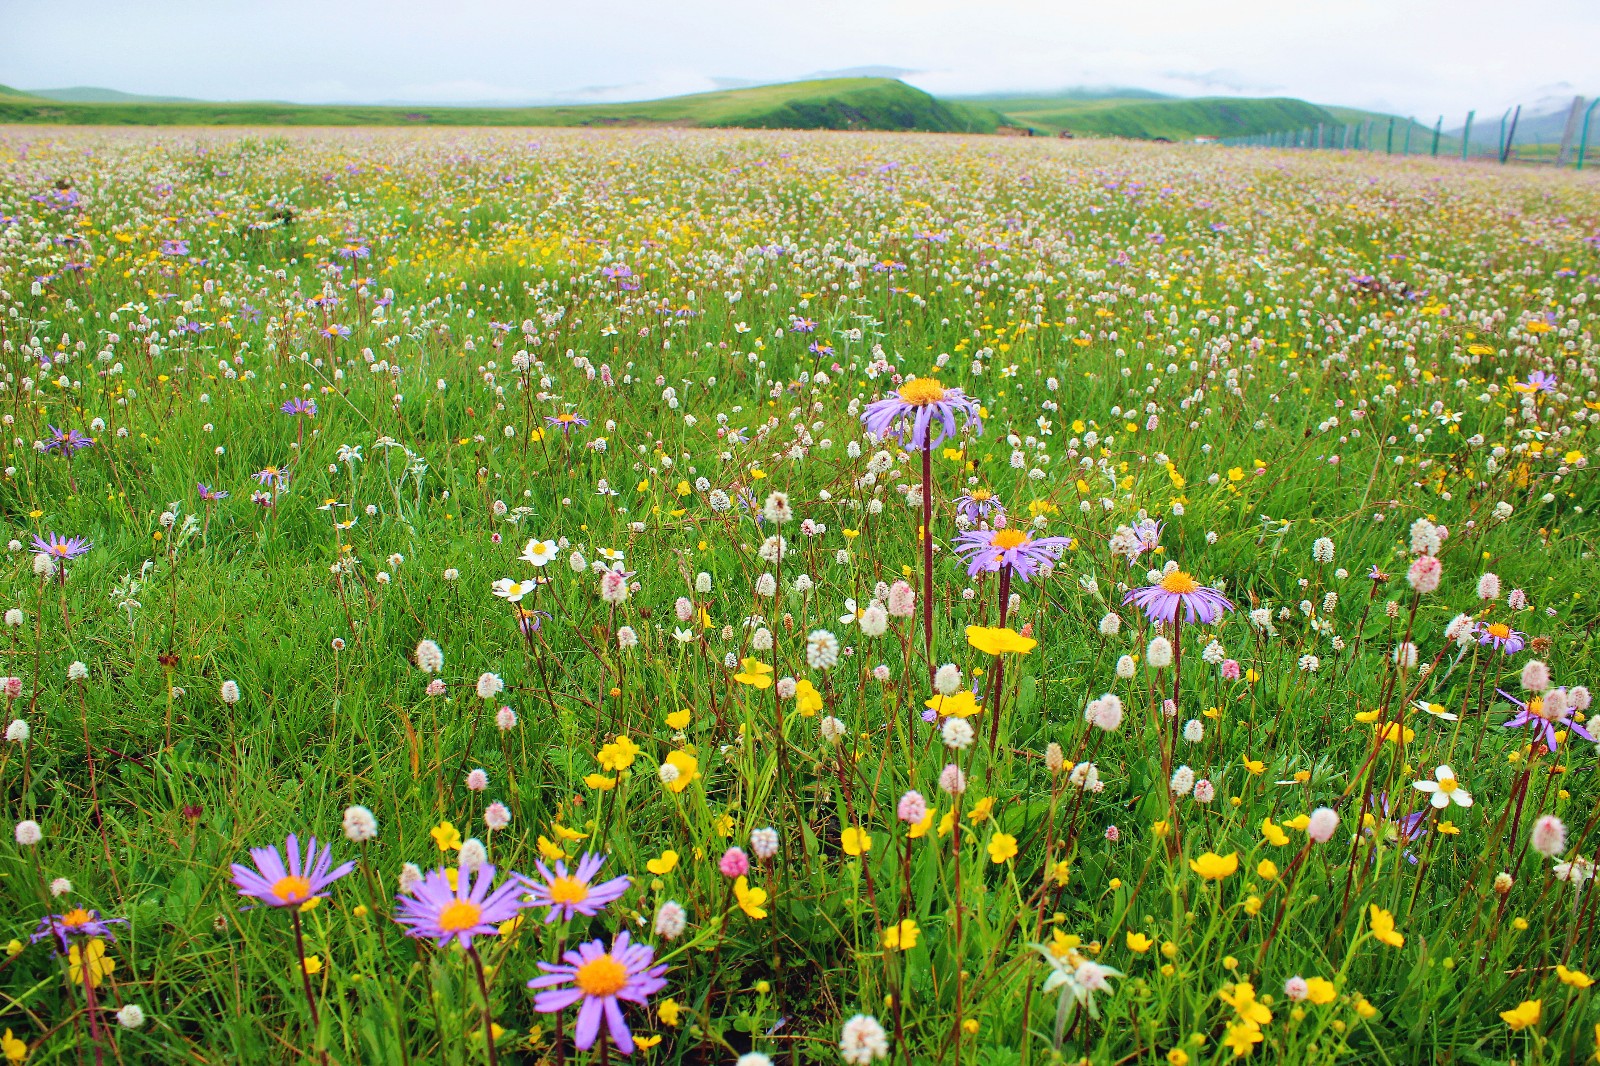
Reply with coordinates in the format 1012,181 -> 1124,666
528,932 -> 667,1055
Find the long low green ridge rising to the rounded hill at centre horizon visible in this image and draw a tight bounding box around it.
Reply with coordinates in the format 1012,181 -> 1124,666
0,78 -> 1003,133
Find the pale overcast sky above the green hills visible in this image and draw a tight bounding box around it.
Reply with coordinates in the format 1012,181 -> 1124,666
0,0 -> 1600,122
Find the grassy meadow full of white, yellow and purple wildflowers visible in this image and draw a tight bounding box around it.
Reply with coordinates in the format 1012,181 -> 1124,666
0,126 -> 1600,1066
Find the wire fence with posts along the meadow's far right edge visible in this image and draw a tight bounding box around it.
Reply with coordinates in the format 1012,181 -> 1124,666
1218,96 -> 1600,170
